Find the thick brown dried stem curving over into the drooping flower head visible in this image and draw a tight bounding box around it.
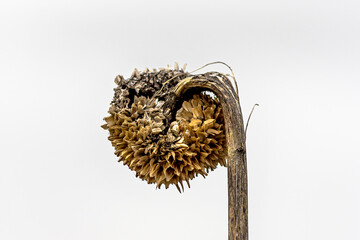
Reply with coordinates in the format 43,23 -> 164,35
175,75 -> 248,240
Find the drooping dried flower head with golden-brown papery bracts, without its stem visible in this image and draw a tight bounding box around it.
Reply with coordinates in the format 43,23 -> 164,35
102,65 -> 226,192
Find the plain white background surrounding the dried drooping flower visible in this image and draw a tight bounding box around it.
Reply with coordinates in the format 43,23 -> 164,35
0,0 -> 360,240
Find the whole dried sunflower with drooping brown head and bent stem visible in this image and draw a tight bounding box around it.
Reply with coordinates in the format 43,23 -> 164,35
102,62 -> 251,240
